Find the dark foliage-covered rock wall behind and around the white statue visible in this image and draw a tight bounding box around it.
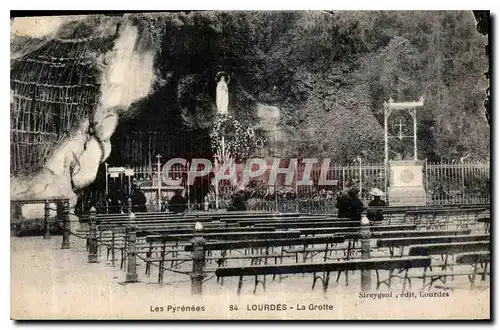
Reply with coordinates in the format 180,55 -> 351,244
120,11 -> 490,162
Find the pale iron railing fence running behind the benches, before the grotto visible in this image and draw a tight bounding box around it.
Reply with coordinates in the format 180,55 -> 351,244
68,161 -> 491,213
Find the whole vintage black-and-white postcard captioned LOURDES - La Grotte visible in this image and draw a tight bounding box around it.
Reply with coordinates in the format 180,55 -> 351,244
10,10 -> 492,320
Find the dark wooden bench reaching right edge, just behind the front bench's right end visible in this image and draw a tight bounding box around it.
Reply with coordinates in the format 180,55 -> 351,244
408,241 -> 491,289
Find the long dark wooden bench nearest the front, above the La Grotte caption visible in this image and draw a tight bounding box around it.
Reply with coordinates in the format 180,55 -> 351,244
215,257 -> 431,295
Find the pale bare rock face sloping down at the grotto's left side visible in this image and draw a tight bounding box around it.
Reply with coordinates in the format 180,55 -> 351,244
11,18 -> 155,217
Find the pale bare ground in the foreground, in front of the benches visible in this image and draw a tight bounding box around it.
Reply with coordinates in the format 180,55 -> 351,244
11,229 -> 490,319
